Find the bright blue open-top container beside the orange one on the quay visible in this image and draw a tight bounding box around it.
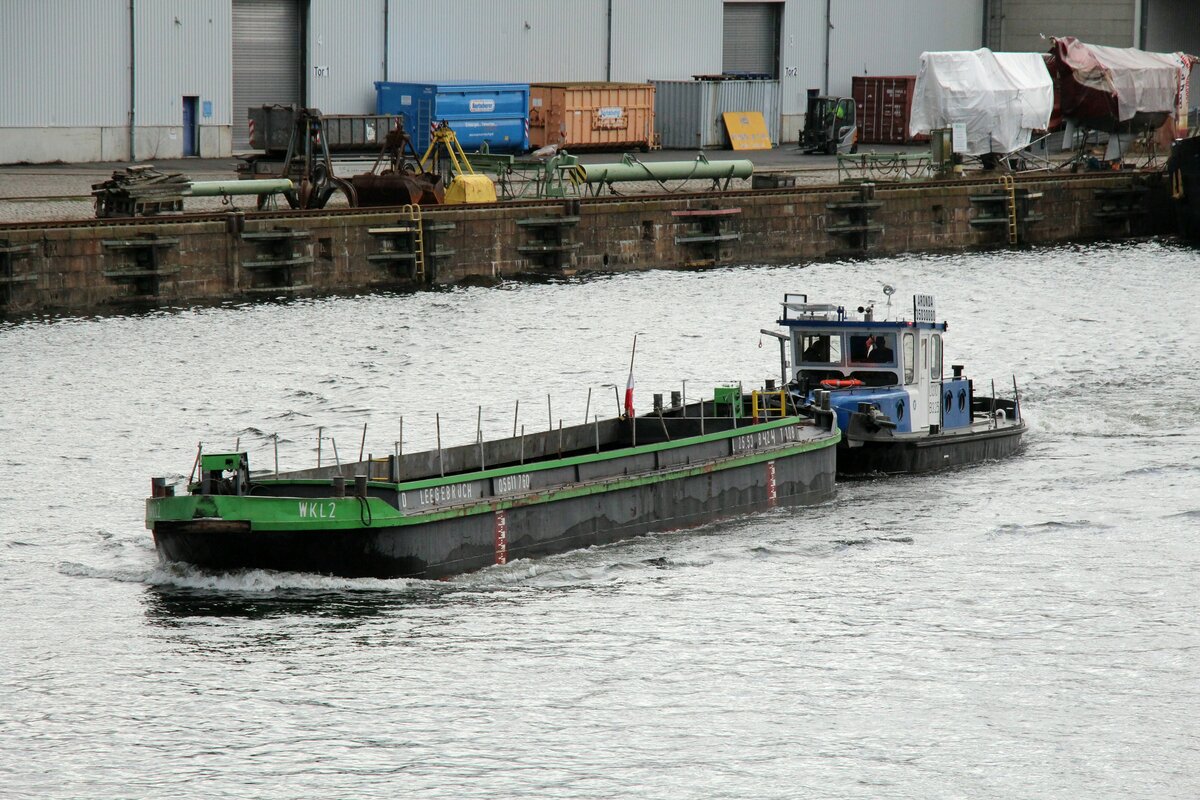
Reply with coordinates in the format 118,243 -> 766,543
376,80 -> 529,154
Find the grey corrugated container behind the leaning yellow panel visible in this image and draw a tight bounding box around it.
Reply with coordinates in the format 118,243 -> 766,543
650,80 -> 779,150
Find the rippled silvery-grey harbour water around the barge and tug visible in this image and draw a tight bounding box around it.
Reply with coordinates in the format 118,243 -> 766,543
0,242 -> 1200,798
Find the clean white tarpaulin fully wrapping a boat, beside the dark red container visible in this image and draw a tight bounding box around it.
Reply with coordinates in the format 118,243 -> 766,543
908,48 -> 1054,156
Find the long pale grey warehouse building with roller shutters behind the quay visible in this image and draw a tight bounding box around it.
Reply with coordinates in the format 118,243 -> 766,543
0,0 -> 1200,163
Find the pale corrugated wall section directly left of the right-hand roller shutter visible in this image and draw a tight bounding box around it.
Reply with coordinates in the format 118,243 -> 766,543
609,0 -> 722,83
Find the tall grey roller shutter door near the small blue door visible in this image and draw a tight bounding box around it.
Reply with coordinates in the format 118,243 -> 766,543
233,0 -> 304,150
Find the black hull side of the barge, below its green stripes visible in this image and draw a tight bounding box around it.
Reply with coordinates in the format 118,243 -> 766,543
154,446 -> 836,578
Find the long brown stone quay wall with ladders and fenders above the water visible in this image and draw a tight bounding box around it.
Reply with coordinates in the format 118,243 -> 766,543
0,173 -> 1169,317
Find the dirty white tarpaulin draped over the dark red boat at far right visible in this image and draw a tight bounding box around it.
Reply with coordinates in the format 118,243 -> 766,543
1055,36 -> 1190,122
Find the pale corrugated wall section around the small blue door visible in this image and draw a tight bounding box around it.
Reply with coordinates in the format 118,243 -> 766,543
134,0 -> 233,127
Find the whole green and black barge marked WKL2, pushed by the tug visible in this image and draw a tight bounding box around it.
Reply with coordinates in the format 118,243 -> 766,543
146,387 -> 841,578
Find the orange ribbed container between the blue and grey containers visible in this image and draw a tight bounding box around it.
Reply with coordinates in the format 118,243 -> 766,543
529,82 -> 654,150
